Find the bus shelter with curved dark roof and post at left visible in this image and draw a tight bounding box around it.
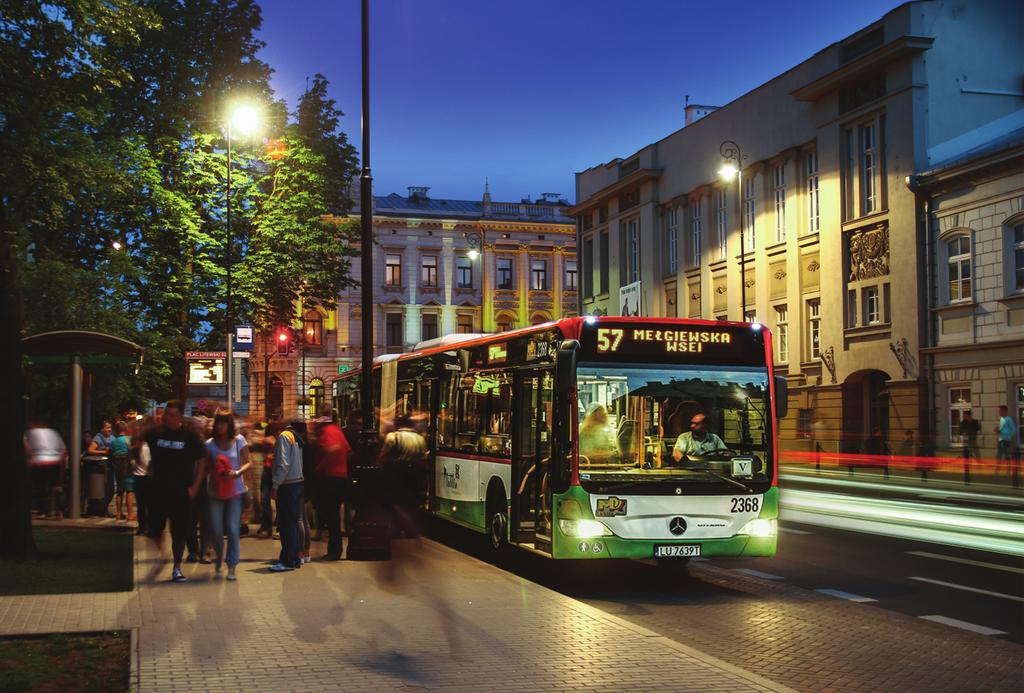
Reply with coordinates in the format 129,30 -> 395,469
22,330 -> 145,519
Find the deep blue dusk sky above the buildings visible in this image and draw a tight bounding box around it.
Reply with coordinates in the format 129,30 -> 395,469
261,0 -> 901,201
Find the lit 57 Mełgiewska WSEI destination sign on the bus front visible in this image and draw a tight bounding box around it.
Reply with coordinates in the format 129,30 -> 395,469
582,320 -> 764,364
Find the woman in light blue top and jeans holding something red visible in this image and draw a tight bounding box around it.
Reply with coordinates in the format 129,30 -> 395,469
206,409 -> 251,580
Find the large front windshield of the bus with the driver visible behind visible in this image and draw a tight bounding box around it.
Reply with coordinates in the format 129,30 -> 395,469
577,363 -> 772,492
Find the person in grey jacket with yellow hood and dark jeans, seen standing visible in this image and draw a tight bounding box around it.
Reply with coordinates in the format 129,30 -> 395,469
270,420 -> 306,572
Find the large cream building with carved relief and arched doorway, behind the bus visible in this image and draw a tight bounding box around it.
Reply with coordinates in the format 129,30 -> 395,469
571,0 -> 1024,450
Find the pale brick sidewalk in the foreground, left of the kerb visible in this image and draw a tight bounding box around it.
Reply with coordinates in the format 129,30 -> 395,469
0,524 -> 787,693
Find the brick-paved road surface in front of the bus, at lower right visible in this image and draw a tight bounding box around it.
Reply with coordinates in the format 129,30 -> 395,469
578,562 -> 1024,692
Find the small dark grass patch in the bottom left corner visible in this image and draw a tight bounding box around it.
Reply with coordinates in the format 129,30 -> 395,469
0,631 -> 131,693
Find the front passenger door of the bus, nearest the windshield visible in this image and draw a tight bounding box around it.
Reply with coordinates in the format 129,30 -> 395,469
511,370 -> 554,552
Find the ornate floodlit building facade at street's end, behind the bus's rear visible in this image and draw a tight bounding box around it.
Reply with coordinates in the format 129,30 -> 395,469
250,187 -> 579,418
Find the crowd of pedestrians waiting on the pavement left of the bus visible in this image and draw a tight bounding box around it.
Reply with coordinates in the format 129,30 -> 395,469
25,400 -> 427,582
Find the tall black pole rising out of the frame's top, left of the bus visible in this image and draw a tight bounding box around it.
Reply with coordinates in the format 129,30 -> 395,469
359,0 -> 374,441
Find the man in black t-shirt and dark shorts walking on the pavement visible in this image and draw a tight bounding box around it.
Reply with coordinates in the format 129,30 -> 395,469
145,399 -> 206,582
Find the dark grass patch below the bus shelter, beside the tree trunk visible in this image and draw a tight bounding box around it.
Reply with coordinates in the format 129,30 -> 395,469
0,527 -> 133,596
